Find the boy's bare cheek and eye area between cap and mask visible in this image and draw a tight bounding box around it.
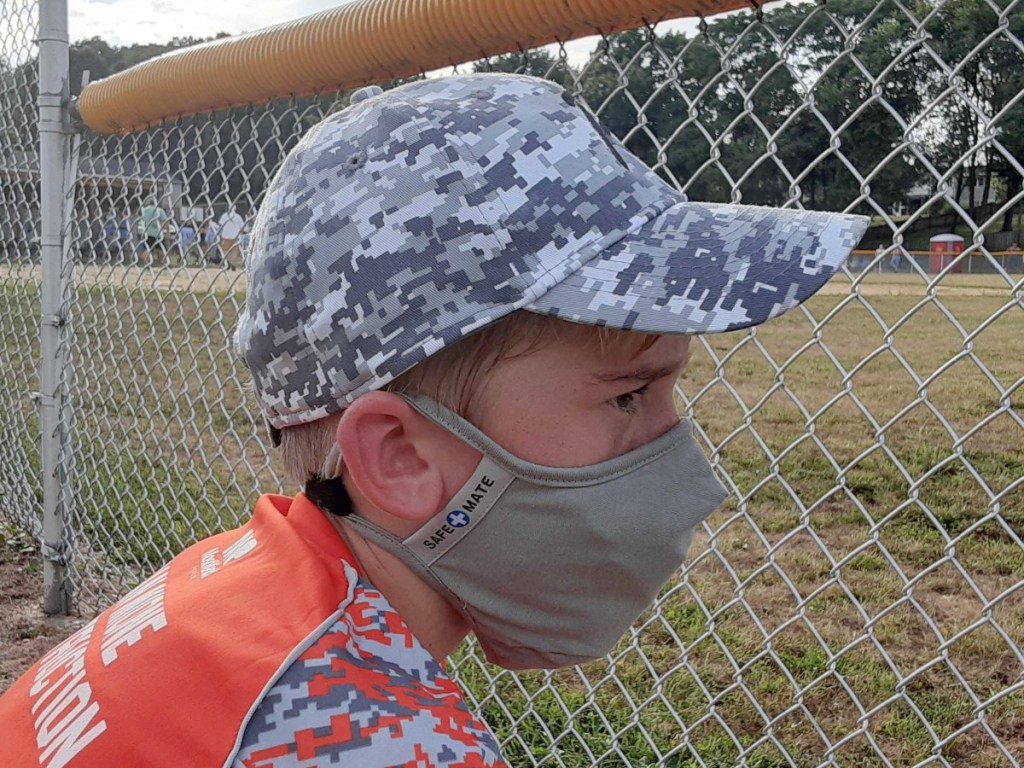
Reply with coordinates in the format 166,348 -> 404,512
469,328 -> 689,471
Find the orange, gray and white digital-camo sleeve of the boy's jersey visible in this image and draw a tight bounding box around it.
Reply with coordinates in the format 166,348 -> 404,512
233,566 -> 505,768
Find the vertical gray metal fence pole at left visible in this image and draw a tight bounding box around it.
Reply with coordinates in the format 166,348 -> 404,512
37,0 -> 71,613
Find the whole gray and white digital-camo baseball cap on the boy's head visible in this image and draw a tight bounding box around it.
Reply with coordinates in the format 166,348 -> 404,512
234,75 -> 867,436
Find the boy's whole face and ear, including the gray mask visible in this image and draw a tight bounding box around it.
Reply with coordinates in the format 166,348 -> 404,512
338,327 -> 708,669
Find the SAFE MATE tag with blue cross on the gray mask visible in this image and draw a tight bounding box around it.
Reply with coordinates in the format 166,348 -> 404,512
403,456 -> 515,565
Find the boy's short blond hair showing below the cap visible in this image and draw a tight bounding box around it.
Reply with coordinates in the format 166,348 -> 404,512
281,309 -> 657,484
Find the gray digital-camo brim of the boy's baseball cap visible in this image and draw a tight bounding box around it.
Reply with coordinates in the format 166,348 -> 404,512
524,202 -> 869,334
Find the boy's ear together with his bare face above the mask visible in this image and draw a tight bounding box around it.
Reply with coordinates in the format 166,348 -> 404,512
331,321 -> 689,539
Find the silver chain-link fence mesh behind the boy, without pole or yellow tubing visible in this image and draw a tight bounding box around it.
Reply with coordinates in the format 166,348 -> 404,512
0,0 -> 1024,767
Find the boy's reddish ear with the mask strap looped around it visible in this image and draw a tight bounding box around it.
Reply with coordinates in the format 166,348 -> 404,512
337,391 -> 446,522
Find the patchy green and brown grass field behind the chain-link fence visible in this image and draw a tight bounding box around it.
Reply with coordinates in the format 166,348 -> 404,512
0,267 -> 1024,768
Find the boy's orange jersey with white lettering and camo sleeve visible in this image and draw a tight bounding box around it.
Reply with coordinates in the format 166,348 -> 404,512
0,496 -> 504,768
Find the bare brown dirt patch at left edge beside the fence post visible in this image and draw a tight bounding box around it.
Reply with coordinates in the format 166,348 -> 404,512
0,527 -> 85,693
